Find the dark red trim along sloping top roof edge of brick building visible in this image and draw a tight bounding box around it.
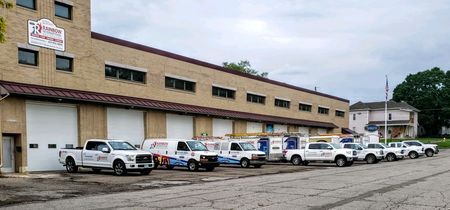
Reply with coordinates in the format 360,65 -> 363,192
91,32 -> 350,103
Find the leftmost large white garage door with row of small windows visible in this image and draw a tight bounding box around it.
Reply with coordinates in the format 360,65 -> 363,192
26,102 -> 78,171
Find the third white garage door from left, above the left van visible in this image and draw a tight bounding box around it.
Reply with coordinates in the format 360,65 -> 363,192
166,114 -> 194,139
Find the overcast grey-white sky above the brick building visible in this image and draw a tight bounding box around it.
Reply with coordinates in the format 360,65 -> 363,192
92,0 -> 450,103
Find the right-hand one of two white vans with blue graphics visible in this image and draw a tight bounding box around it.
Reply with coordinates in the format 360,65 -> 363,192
204,140 -> 266,168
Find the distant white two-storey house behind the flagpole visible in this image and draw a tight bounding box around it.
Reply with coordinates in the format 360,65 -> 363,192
349,101 -> 419,138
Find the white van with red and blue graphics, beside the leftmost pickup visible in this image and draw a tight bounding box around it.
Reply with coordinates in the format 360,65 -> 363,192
141,139 -> 219,171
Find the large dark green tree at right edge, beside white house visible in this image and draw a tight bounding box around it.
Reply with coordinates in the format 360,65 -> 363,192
393,67 -> 450,136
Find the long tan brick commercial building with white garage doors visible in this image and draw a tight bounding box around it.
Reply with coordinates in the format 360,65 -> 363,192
0,0 -> 349,172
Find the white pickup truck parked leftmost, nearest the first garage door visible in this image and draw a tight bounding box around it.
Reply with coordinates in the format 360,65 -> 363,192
59,139 -> 153,176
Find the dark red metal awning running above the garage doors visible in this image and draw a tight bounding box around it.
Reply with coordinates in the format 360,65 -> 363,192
0,81 -> 337,128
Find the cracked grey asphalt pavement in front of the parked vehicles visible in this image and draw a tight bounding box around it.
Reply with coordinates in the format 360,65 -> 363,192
6,150 -> 450,209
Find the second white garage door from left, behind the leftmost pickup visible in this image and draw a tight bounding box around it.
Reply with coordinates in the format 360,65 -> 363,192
107,108 -> 145,147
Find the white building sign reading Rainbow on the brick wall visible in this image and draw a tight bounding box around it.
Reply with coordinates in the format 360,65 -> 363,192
28,19 -> 66,51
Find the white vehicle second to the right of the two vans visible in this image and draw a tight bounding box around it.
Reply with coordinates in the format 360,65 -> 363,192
341,143 -> 384,164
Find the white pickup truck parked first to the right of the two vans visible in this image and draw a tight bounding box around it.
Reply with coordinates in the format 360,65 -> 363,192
283,142 -> 358,167
